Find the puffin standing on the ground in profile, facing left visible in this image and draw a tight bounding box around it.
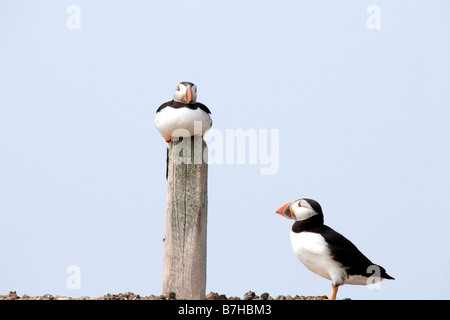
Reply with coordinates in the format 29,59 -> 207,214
276,198 -> 394,300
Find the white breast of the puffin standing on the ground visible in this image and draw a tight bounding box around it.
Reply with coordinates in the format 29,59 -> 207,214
291,231 -> 347,285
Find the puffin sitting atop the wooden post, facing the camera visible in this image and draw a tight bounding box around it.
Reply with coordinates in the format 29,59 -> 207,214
154,81 -> 212,143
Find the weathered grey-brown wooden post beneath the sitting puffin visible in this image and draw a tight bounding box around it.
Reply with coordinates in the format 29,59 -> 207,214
163,137 -> 208,300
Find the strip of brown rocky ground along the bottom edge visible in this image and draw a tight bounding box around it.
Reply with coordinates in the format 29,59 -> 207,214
0,291 -> 327,300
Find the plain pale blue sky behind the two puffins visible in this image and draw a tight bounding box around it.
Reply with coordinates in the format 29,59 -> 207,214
0,0 -> 450,299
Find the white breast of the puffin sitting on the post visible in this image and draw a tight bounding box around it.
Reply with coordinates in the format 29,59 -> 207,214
154,107 -> 212,140
